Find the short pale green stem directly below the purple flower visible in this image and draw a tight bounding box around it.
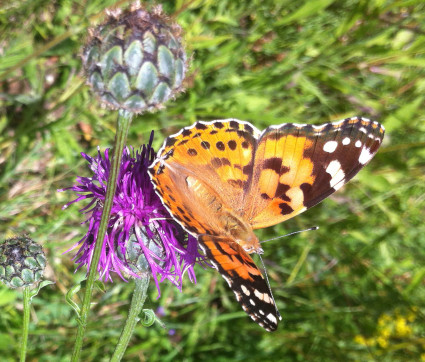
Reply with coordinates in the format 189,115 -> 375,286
111,274 -> 150,362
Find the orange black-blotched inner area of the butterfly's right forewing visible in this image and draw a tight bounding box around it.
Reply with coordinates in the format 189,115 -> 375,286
245,127 -> 315,229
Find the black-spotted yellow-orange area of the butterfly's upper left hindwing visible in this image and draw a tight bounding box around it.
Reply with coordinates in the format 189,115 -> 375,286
152,120 -> 259,219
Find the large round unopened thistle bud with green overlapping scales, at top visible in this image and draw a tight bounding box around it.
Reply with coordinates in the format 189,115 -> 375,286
82,4 -> 186,113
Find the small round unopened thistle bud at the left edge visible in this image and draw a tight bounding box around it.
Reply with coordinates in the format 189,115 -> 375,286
0,235 -> 46,288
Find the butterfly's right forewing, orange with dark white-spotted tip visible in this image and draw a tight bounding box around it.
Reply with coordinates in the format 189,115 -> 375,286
244,117 -> 384,229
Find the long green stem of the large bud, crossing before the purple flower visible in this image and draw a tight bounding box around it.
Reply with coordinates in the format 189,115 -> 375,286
71,109 -> 133,362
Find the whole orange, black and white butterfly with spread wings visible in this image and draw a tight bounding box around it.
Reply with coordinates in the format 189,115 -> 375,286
149,117 -> 384,331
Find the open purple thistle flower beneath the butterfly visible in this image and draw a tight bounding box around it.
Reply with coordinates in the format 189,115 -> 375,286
58,132 -> 202,293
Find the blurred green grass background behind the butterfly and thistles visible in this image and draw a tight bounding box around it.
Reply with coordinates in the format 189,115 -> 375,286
0,0 -> 425,361
